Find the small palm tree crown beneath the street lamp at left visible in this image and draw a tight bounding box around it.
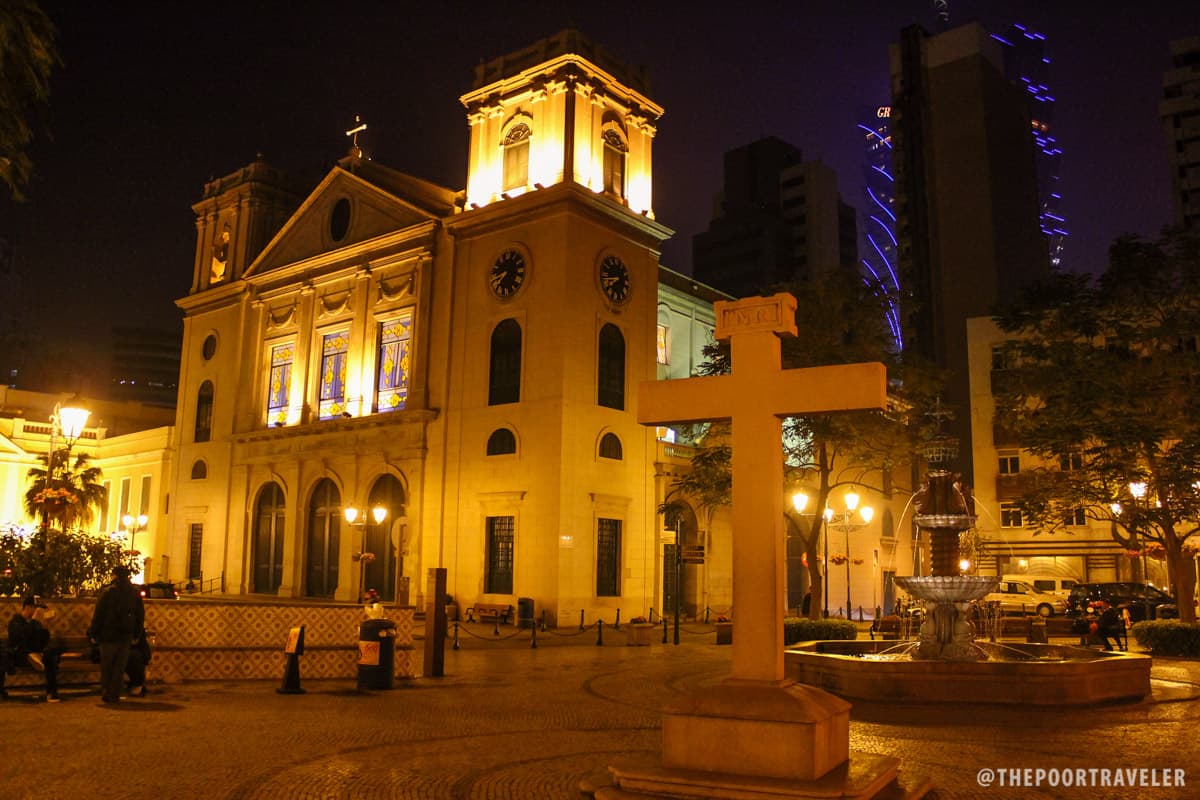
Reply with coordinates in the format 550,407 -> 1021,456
25,447 -> 108,530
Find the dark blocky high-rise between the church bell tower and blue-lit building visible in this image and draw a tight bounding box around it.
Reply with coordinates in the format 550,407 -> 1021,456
692,137 -> 857,296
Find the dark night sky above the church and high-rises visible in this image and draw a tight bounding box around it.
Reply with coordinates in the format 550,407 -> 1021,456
0,0 -> 1200,376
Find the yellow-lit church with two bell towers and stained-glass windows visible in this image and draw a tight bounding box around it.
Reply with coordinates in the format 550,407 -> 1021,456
168,30 -> 727,625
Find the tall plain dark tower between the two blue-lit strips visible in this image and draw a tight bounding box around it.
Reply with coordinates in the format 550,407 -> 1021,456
889,23 -> 1049,480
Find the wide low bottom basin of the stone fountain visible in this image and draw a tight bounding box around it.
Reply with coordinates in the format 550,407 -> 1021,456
784,640 -> 1153,705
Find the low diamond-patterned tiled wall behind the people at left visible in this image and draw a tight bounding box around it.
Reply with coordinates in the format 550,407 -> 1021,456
0,597 -> 415,685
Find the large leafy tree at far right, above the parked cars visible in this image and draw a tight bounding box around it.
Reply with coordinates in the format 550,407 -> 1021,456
996,231 -> 1200,622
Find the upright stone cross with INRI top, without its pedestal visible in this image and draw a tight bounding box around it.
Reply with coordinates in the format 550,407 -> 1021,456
637,294 -> 887,682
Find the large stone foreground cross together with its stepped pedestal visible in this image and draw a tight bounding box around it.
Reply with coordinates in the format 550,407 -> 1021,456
584,294 -> 921,800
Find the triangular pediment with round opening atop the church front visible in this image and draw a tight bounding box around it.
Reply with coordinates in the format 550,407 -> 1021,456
246,161 -> 455,277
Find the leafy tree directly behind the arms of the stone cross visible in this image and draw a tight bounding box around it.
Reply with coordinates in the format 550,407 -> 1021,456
672,270 -> 942,619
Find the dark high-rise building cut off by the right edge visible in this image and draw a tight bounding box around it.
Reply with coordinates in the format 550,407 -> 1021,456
1158,36 -> 1200,230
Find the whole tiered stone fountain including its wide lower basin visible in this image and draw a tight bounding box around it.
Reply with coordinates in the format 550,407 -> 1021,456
785,439 -> 1151,705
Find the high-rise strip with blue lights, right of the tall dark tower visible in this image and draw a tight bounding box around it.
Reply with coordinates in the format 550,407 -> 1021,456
991,24 -> 1068,267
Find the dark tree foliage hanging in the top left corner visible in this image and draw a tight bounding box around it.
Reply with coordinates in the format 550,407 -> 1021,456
0,0 -> 60,200
